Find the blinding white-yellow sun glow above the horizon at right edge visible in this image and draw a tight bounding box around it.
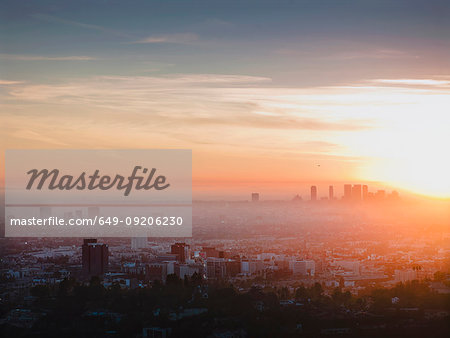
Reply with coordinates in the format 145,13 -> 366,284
342,88 -> 450,198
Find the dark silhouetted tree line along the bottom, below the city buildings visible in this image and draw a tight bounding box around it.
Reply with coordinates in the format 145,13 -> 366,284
0,274 -> 450,337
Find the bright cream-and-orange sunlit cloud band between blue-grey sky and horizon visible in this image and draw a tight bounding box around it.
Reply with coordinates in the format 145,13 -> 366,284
0,74 -> 450,196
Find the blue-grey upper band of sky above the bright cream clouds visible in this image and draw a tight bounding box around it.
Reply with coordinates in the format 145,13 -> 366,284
0,0 -> 450,86
